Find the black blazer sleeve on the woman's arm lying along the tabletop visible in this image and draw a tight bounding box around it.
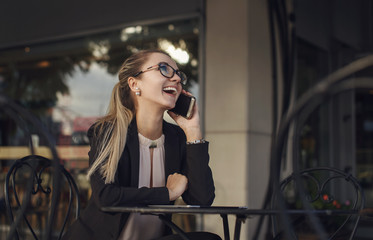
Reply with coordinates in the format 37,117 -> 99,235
87,124 -> 170,207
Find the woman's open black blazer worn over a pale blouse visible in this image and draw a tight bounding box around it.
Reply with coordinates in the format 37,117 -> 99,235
63,119 -> 215,240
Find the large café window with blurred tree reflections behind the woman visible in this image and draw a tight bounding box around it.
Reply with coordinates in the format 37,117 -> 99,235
0,18 -> 200,206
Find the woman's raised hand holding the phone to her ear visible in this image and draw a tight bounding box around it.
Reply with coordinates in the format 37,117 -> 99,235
167,90 -> 202,142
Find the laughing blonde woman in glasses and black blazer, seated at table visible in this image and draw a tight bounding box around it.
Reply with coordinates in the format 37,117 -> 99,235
64,50 -> 219,240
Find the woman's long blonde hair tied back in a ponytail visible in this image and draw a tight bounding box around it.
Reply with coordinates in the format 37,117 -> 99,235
87,50 -> 169,184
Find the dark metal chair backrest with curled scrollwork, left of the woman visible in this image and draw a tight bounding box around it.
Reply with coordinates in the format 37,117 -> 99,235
4,155 -> 80,239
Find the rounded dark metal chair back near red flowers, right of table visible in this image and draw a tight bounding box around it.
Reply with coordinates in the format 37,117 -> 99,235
272,167 -> 365,239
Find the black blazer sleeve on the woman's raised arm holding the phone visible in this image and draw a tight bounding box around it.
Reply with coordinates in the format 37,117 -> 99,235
182,136 -> 215,206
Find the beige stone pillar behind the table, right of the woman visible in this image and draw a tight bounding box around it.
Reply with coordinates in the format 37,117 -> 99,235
204,0 -> 272,239
